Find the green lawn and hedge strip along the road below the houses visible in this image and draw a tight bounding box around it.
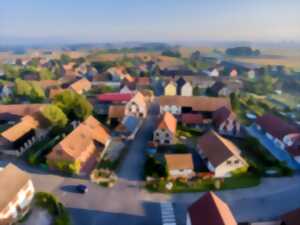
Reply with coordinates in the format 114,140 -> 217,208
146,173 -> 260,193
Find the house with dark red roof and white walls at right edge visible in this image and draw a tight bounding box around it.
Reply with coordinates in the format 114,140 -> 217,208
255,113 -> 300,162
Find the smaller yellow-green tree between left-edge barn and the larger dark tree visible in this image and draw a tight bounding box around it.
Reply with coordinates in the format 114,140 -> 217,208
41,104 -> 68,128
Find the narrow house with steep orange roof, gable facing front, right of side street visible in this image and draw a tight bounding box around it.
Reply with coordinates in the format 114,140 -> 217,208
153,112 -> 177,145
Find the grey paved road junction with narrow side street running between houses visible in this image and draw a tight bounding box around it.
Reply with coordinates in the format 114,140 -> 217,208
0,104 -> 300,225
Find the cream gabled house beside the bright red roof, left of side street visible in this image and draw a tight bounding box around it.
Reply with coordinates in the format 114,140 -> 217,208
125,92 -> 148,118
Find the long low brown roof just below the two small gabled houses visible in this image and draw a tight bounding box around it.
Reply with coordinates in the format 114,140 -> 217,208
159,96 -> 231,112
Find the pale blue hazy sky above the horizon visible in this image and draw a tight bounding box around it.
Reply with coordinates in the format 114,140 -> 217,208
0,0 -> 300,42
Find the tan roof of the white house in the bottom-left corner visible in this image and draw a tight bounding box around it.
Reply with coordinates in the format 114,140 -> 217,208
0,163 -> 30,212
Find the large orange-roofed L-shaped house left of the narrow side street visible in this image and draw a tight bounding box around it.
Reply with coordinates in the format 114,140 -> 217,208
47,116 -> 111,174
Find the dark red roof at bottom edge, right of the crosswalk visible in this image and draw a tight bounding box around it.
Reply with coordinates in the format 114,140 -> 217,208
188,192 -> 237,225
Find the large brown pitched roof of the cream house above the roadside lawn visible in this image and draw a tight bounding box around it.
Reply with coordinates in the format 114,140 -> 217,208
198,131 -> 246,167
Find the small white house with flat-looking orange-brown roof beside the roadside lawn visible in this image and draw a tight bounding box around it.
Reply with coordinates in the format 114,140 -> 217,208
165,154 -> 195,179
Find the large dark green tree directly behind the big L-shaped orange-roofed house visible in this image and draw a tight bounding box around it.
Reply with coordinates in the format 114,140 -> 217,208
54,90 -> 93,120
